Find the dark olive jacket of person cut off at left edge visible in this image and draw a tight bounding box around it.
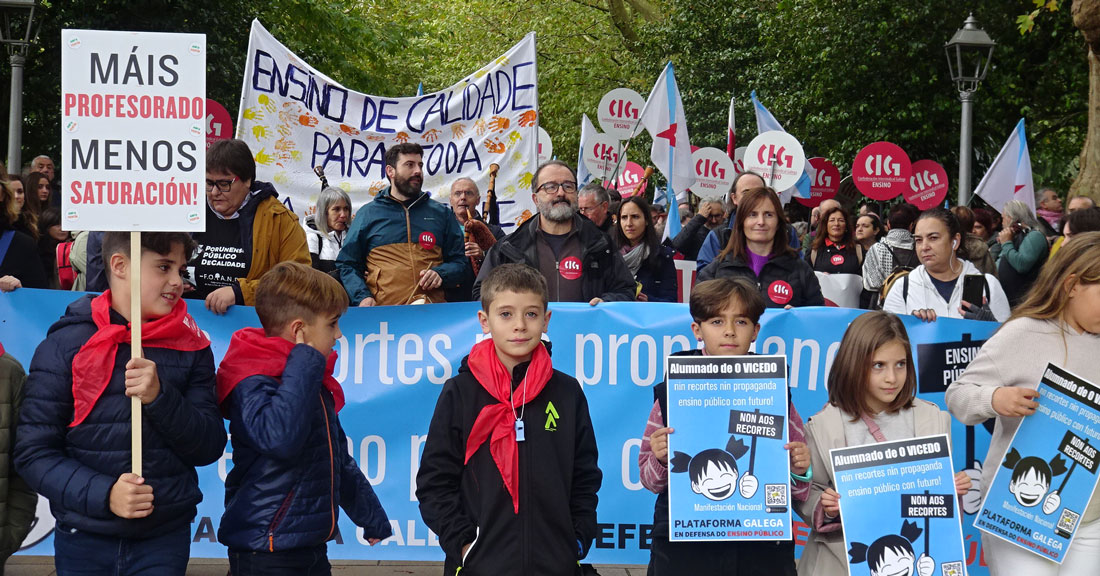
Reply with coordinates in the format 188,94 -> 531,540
0,347 -> 39,564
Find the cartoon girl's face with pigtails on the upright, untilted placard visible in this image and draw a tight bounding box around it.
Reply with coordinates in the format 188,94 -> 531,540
669,436 -> 758,500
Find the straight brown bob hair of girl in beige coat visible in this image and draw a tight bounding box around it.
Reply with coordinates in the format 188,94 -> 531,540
828,309 -> 915,422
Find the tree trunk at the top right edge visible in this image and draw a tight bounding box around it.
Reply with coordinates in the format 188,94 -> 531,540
1069,0 -> 1100,203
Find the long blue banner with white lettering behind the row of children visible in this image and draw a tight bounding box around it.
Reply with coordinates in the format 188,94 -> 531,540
0,288 -> 998,575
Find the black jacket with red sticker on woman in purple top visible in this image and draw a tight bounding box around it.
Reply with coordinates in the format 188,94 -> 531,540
697,251 -> 825,308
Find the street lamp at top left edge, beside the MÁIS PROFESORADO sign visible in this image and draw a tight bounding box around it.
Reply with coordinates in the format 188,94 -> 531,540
0,0 -> 39,174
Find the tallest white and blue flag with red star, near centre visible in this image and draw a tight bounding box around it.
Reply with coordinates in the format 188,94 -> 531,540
640,62 -> 695,237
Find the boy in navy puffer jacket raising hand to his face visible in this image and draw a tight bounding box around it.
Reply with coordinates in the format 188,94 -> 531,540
218,262 -> 392,576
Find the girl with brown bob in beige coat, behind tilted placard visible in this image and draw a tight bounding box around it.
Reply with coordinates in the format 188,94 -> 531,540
799,311 -> 970,576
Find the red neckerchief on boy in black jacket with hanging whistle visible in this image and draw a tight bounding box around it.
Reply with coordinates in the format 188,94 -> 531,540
464,339 -> 553,514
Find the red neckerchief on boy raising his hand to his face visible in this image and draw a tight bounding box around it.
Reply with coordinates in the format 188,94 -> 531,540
218,328 -> 344,412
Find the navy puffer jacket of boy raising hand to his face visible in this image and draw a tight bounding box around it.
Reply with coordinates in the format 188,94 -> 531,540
218,344 -> 392,552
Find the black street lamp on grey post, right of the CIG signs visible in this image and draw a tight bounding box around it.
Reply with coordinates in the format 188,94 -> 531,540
944,13 -> 997,206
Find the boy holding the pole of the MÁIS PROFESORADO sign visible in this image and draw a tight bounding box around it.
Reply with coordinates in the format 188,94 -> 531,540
14,232 -> 226,576
